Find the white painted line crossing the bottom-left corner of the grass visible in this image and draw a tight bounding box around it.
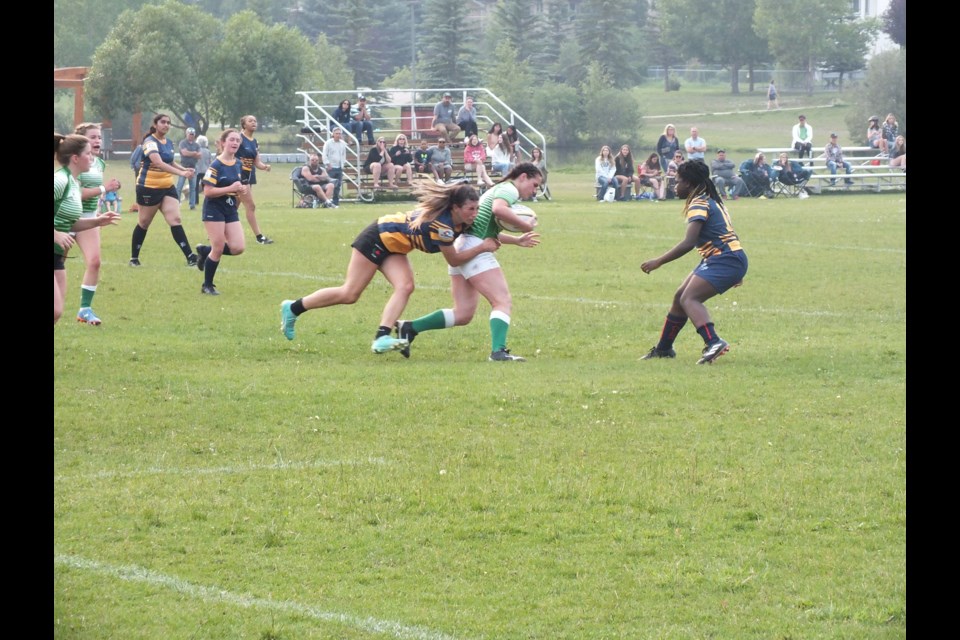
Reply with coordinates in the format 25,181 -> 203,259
53,554 -> 468,640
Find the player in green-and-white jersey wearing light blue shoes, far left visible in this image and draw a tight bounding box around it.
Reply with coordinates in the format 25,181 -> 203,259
73,122 -> 120,326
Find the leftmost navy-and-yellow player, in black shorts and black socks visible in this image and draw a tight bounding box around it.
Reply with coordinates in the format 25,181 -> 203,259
130,113 -> 197,267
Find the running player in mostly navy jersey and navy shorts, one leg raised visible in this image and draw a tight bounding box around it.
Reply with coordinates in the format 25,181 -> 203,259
197,129 -> 250,296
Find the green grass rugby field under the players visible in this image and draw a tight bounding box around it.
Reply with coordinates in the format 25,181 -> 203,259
54,151 -> 906,640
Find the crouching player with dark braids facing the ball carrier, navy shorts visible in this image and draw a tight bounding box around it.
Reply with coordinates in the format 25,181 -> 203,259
640,160 -> 747,364
